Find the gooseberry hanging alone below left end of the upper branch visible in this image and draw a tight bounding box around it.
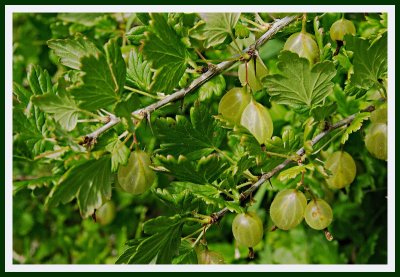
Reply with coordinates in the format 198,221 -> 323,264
118,150 -> 156,194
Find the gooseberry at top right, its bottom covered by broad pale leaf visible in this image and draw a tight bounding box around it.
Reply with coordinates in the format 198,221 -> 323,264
283,32 -> 319,64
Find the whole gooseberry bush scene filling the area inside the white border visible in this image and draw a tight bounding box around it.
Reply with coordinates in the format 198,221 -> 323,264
13,13 -> 388,264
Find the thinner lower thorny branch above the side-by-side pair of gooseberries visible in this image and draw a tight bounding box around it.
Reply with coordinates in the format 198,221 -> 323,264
210,106 -> 375,224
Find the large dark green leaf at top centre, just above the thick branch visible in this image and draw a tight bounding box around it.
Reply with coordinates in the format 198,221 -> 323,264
143,13 -> 188,93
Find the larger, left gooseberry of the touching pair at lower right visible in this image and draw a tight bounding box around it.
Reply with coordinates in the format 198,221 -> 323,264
270,189 -> 307,230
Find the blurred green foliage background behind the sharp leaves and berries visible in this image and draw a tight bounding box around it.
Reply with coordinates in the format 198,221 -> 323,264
13,13 -> 387,264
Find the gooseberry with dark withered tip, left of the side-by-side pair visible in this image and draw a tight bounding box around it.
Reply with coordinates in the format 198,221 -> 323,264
232,212 -> 264,247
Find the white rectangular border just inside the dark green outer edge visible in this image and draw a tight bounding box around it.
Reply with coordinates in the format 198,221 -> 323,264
4,5 -> 395,272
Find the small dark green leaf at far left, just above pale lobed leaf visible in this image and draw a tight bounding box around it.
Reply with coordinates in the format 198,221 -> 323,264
28,65 -> 53,95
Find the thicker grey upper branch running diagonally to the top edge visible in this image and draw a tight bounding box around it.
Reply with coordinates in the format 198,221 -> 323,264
84,16 -> 297,142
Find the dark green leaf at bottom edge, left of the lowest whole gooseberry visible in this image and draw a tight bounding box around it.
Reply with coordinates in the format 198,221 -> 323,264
123,215 -> 184,264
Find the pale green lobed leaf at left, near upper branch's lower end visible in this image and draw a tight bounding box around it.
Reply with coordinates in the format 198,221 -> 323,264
32,89 -> 81,131
